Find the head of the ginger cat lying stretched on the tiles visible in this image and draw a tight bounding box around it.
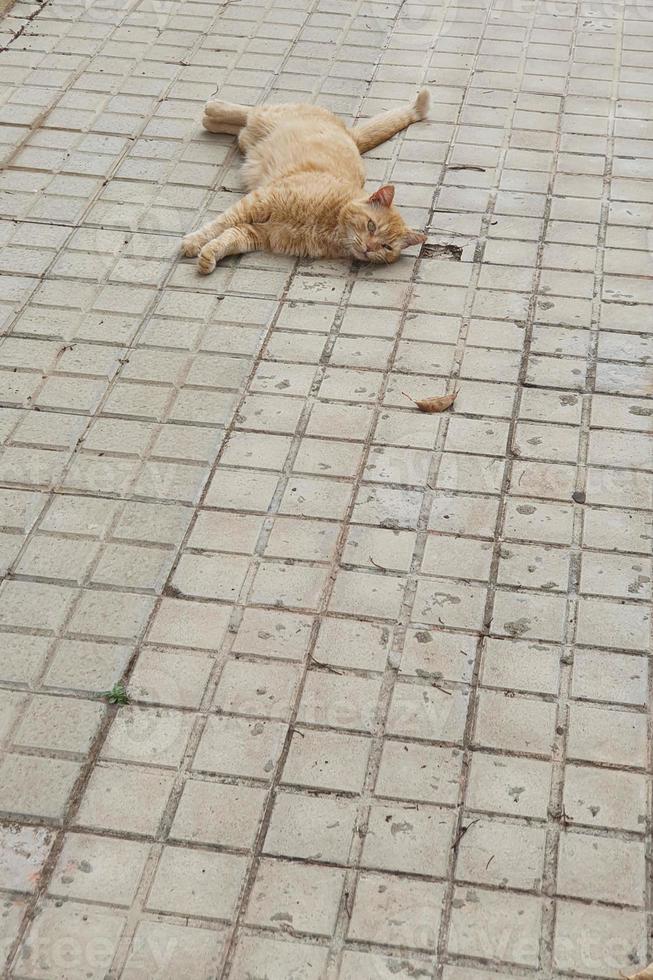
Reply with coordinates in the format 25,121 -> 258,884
343,184 -> 426,262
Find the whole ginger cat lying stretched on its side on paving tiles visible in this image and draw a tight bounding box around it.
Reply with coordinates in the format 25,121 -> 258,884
182,89 -> 429,275
